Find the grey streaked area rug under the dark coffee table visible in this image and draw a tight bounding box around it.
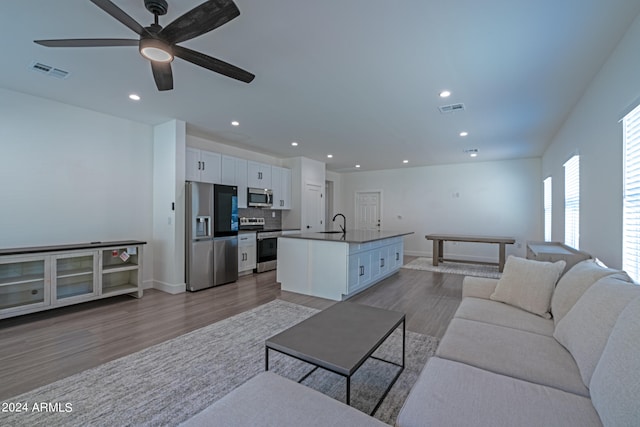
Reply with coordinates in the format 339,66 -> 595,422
0,300 -> 438,426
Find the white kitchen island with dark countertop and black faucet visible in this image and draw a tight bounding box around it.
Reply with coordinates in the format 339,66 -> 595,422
276,230 -> 413,301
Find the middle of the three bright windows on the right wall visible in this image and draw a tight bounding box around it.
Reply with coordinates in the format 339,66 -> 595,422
564,154 -> 580,249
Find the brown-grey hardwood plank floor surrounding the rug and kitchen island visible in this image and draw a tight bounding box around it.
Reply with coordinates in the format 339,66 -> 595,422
0,257 -> 463,401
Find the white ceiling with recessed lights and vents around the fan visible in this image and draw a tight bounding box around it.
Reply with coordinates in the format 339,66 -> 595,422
0,0 -> 640,171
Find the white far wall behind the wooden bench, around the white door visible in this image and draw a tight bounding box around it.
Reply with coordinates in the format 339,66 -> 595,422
341,159 -> 543,262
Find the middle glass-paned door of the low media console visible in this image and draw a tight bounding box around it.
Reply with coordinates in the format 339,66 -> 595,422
53,251 -> 97,304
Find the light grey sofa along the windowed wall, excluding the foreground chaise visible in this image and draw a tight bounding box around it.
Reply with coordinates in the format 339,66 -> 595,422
396,257 -> 640,427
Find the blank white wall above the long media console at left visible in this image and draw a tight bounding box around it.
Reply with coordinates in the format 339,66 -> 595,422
0,89 -> 153,282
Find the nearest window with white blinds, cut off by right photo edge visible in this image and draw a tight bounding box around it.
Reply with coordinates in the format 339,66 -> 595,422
622,106 -> 640,281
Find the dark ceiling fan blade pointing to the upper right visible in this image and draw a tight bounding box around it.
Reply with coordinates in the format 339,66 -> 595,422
160,0 -> 240,44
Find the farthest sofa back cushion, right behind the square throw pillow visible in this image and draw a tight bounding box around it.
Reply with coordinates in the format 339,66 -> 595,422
551,259 -> 631,325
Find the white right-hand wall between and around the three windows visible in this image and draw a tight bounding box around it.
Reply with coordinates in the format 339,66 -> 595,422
542,16 -> 640,268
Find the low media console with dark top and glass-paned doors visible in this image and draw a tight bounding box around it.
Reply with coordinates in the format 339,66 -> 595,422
0,240 -> 146,319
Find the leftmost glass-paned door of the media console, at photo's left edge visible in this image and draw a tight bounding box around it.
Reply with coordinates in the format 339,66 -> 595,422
0,257 -> 50,312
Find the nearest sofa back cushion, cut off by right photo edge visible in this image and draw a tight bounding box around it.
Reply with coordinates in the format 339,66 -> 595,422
590,298 -> 640,427
